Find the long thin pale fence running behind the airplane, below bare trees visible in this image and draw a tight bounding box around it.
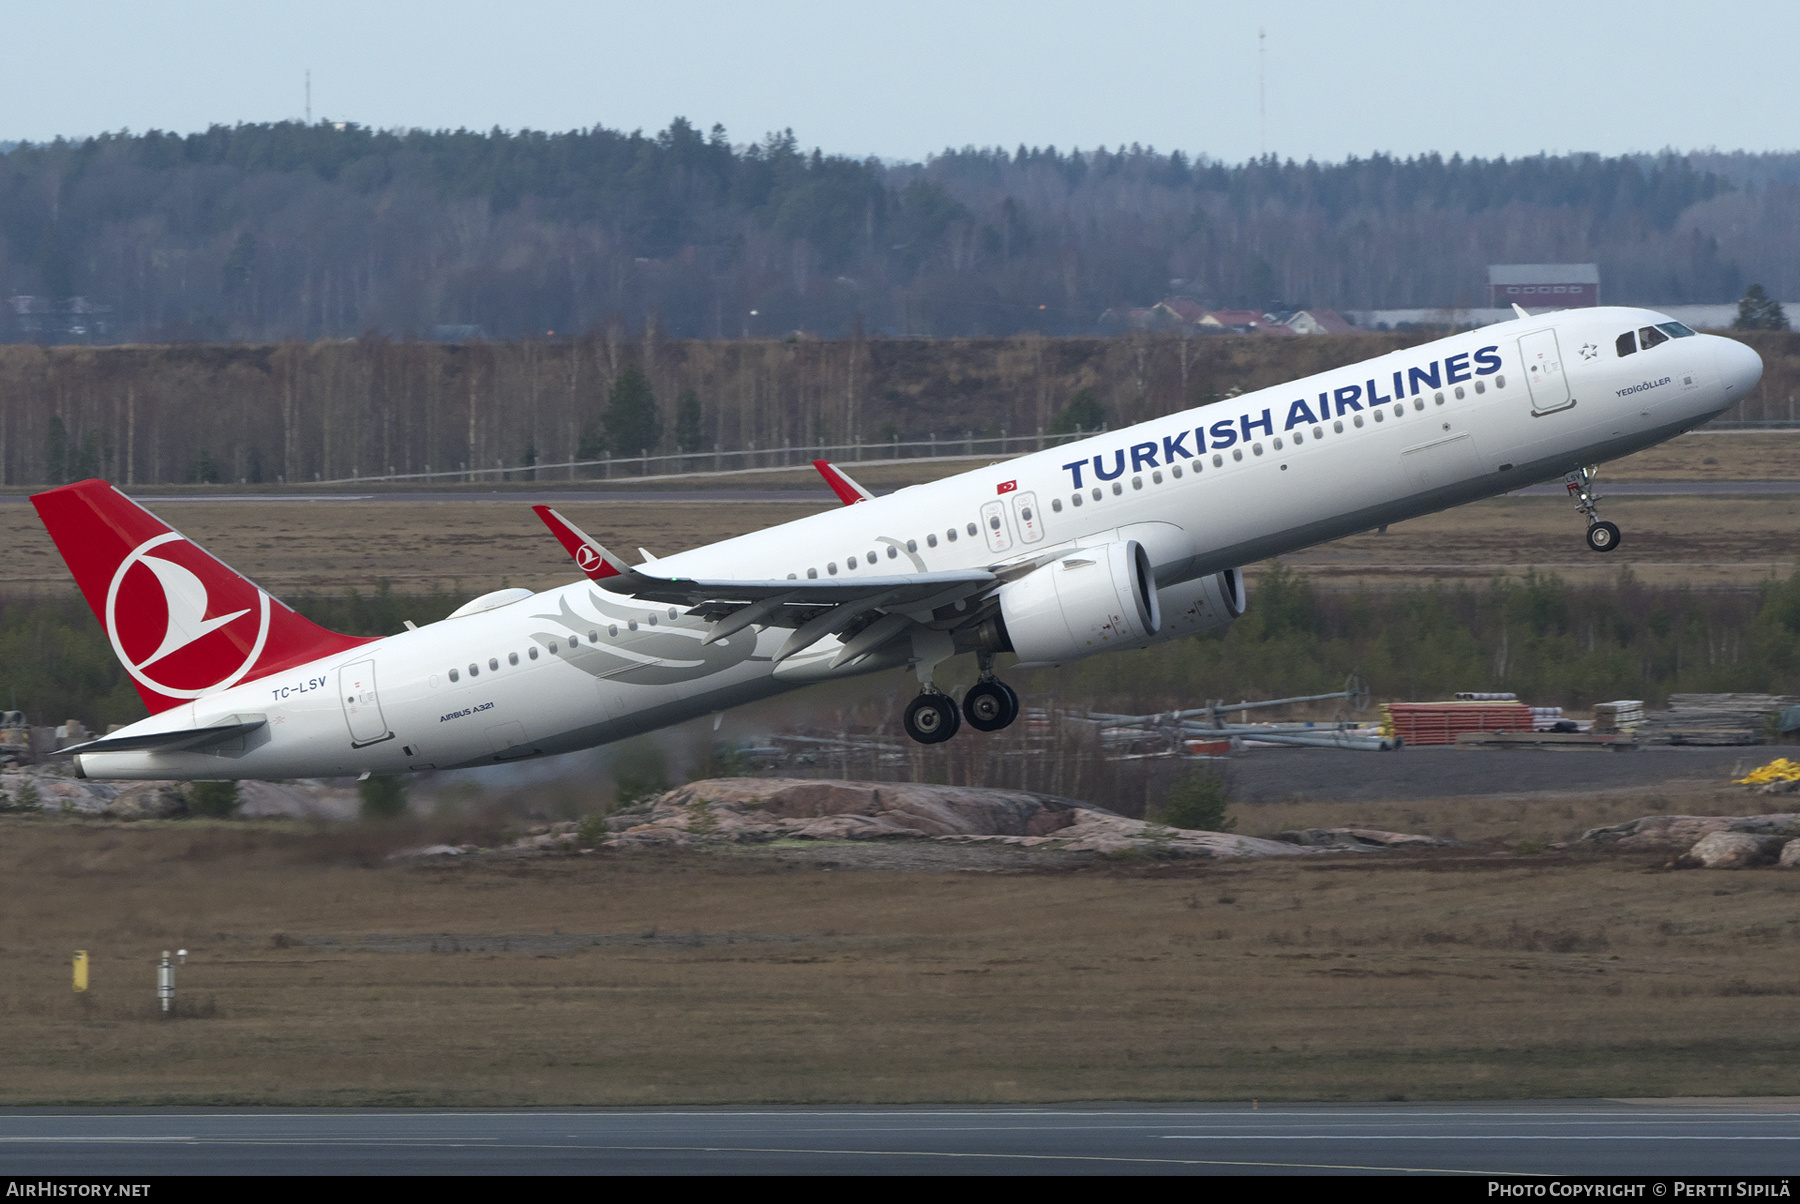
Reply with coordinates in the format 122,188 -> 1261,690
313,427 -> 1105,484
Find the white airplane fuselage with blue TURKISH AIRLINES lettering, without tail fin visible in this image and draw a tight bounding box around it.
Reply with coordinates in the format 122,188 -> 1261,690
79,308 -> 1760,777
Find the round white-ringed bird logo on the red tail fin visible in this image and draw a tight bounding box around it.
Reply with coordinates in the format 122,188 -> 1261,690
106,531 -> 268,698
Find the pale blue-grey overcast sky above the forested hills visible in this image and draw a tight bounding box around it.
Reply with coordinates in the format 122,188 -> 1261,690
0,0 -> 1800,162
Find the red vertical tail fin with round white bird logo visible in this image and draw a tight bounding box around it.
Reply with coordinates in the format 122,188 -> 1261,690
31,481 -> 371,714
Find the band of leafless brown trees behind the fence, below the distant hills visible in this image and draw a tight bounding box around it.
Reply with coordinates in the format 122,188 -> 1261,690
0,326 -> 1800,486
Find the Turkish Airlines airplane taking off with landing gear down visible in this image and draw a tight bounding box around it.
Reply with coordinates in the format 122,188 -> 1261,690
32,308 -> 1762,779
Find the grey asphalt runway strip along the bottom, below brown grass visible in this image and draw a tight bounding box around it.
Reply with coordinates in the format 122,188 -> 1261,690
0,1100 -> 1800,1177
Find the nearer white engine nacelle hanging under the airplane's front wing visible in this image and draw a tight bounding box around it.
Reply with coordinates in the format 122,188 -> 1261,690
999,540 -> 1163,664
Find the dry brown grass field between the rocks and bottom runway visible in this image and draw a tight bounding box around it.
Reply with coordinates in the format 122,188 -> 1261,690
10,803 -> 1800,1105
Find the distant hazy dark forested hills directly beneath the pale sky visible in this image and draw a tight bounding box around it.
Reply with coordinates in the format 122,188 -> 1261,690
0,119 -> 1800,342
